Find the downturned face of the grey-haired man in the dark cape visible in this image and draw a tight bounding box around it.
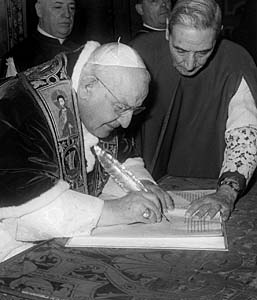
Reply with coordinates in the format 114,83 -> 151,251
169,25 -> 216,76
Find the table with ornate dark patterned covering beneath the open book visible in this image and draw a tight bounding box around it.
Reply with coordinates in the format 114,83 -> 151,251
0,176 -> 257,300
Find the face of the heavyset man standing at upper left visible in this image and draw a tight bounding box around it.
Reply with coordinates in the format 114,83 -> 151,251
36,0 -> 75,39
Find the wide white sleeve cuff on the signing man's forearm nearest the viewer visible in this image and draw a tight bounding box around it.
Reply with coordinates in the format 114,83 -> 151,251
16,184 -> 104,241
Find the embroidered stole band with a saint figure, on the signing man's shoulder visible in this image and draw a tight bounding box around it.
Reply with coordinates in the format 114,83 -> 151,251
20,54 -> 88,194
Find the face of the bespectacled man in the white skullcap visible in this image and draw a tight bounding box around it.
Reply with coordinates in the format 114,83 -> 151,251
78,77 -> 144,138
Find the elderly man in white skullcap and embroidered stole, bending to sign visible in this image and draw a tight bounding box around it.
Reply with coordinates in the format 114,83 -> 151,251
0,42 -> 172,259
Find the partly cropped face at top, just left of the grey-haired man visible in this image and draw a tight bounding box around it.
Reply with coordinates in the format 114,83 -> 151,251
137,0 -> 171,29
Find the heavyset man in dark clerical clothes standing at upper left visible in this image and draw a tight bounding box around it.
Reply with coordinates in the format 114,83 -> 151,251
0,0 -> 78,77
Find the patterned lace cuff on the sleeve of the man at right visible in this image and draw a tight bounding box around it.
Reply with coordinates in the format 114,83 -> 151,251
220,126 -> 257,183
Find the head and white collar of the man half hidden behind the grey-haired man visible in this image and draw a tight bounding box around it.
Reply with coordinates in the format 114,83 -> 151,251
135,0 -> 171,35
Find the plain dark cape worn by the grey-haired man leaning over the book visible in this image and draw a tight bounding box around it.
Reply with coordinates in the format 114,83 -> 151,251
132,33 -> 257,179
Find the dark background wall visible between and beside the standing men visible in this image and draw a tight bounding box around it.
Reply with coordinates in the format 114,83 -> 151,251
0,0 -> 248,59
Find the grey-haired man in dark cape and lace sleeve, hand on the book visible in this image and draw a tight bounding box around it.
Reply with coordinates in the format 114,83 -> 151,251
133,0 -> 257,219
